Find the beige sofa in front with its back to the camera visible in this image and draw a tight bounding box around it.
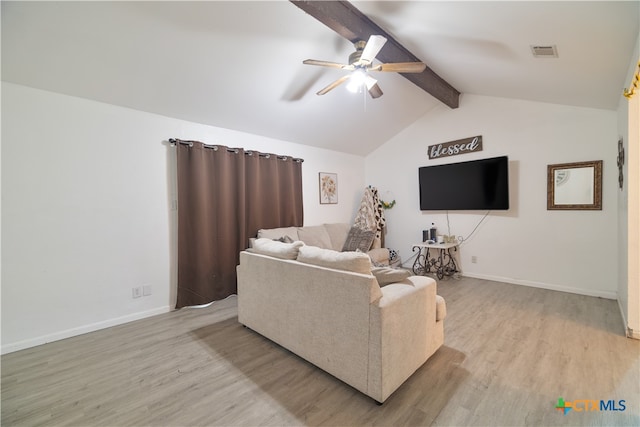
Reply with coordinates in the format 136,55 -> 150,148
237,239 -> 446,403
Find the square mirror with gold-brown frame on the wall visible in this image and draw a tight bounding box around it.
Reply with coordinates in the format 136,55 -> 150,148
547,160 -> 602,210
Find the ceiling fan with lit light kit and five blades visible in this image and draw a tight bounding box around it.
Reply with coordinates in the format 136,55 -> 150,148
302,35 -> 427,98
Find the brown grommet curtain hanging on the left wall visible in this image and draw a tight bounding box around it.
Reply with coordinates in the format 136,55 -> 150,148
171,140 -> 303,308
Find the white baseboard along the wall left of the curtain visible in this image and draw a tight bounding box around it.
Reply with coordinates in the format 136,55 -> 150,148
1,305 -> 171,354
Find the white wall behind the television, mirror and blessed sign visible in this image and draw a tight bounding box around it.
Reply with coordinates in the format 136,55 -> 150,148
366,95 -> 618,298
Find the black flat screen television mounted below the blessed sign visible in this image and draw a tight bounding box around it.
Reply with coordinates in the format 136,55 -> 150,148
418,156 -> 509,211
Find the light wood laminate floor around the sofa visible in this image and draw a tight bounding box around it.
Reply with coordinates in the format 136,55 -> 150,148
2,278 -> 640,426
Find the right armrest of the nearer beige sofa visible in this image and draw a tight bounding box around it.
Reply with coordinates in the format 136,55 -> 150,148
369,276 -> 437,402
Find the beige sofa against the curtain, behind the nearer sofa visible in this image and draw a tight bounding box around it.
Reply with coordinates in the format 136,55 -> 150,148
258,223 -> 400,266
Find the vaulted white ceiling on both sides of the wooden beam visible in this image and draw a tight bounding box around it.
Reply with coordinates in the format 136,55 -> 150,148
2,1 -> 640,155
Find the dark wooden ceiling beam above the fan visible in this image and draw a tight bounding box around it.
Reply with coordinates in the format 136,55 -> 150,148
290,0 -> 460,108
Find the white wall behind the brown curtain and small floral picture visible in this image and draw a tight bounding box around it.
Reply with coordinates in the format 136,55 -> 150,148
1,82 -> 365,353
